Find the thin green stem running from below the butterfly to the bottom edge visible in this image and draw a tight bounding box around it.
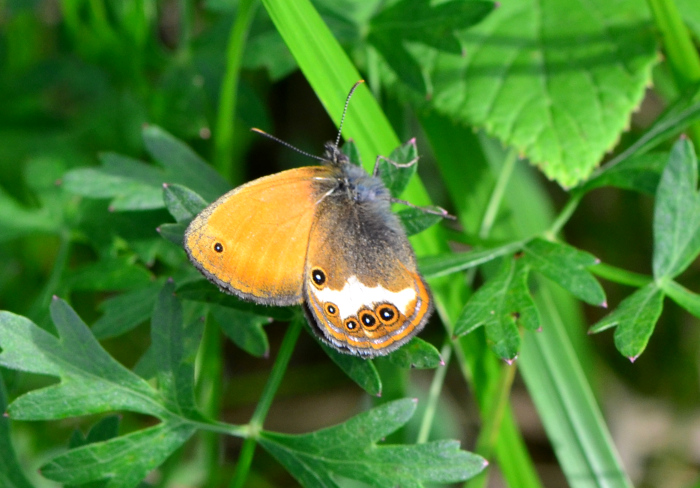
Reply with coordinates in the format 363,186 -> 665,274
229,317 -> 304,488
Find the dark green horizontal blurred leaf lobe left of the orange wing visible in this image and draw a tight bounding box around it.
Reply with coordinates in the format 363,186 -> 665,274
66,257 -> 152,291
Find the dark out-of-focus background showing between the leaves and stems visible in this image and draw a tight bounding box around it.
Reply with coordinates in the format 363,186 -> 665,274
0,0 -> 700,487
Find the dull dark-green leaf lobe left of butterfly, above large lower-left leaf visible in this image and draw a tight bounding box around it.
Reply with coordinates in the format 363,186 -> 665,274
92,280 -> 163,339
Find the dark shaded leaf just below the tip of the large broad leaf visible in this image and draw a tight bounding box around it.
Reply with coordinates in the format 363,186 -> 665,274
581,153 -> 668,195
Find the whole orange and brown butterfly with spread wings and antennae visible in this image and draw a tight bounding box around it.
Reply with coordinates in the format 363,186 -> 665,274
184,82 -> 433,358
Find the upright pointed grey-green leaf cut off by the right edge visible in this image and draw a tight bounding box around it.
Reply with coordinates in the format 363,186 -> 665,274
653,138 -> 700,280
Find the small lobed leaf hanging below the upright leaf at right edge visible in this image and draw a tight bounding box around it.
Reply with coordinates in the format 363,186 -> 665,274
590,283 -> 664,361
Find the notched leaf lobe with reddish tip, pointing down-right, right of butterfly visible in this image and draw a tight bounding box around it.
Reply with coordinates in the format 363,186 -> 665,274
524,238 -> 606,307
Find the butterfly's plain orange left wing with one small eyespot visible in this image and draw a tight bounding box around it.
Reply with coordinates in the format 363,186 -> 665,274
185,166 -> 332,305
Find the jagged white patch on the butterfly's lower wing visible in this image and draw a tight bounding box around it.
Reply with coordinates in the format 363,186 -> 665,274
309,276 -> 416,320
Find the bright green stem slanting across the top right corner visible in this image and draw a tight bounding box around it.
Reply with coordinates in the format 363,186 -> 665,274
647,0 -> 700,146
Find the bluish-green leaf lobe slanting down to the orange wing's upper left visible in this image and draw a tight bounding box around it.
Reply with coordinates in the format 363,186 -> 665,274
143,125 -> 231,202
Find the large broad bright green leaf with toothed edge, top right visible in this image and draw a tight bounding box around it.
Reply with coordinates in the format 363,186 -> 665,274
414,0 -> 658,187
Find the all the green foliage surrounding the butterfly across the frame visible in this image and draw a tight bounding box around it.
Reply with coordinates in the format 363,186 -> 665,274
0,0 -> 700,488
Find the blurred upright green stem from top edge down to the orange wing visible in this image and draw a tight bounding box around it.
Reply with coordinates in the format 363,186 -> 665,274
214,0 -> 258,183
